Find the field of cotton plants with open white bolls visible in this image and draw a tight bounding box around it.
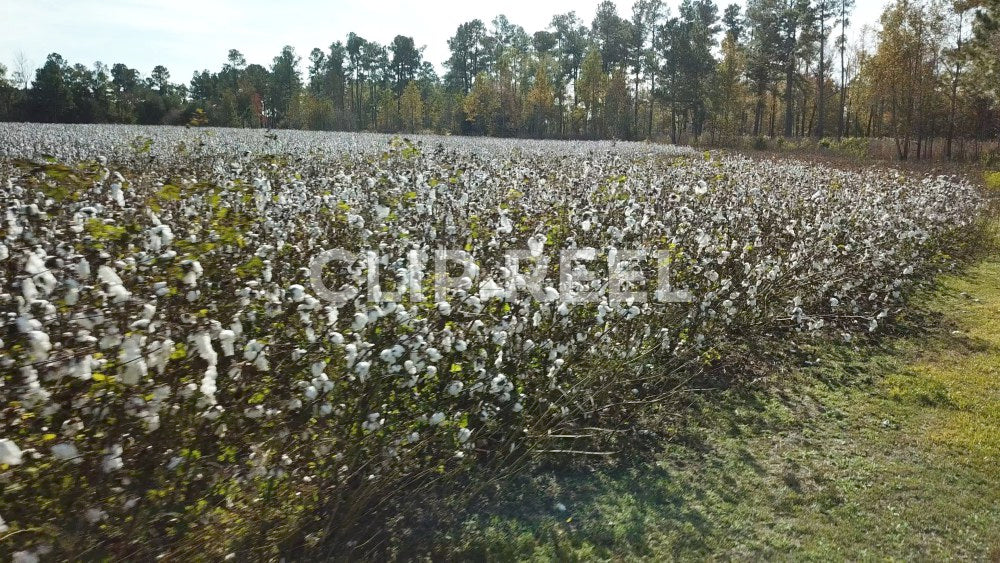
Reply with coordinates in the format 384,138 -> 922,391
0,124 -> 983,560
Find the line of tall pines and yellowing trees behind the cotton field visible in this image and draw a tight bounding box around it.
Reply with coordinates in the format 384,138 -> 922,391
0,0 -> 1000,159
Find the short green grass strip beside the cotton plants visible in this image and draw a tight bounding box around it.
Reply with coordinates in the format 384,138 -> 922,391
430,224 -> 1000,561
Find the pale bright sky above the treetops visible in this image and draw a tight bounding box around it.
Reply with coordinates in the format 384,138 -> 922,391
0,0 -> 887,82
